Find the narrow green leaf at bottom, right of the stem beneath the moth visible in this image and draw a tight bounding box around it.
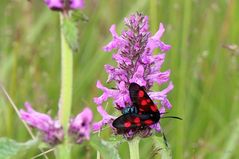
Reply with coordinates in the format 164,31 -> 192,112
152,136 -> 172,159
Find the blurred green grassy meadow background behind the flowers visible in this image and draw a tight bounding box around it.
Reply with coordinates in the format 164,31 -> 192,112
0,0 -> 239,159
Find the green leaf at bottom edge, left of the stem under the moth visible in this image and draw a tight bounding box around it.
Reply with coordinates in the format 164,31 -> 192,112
90,136 -> 120,159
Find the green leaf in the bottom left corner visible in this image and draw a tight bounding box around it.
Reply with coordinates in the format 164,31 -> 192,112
0,138 -> 38,159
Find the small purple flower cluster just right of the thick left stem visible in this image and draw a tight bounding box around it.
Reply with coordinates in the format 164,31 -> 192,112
68,108 -> 93,144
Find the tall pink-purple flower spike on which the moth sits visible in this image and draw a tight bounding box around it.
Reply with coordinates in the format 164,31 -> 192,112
94,13 -> 173,139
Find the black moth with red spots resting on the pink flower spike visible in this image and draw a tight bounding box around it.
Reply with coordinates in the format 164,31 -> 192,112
112,83 -> 160,134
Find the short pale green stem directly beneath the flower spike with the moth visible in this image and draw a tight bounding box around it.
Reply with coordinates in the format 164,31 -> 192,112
128,137 -> 140,159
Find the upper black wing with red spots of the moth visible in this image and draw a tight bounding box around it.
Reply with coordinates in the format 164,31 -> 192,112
129,83 -> 160,116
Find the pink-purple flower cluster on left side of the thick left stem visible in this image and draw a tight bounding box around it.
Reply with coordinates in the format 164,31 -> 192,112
20,102 -> 64,146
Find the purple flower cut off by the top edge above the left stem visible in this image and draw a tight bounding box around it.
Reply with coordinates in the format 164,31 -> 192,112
44,0 -> 84,11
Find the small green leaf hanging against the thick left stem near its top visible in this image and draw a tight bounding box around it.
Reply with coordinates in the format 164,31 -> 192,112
62,18 -> 79,52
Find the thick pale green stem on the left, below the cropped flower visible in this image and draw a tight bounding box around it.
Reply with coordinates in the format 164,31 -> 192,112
56,14 -> 73,159
